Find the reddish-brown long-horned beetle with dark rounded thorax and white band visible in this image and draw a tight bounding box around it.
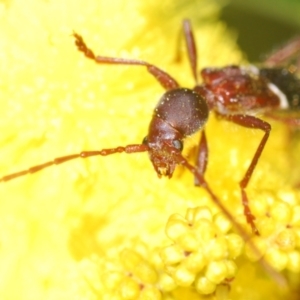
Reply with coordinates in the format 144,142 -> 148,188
0,20 -> 300,235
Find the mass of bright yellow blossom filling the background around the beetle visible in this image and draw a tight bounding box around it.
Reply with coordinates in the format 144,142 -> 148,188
0,0 -> 300,300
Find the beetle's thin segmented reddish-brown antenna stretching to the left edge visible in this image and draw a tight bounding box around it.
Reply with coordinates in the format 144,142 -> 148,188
0,144 -> 148,182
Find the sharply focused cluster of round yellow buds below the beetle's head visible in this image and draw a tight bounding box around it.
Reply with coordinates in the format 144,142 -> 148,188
161,207 -> 243,294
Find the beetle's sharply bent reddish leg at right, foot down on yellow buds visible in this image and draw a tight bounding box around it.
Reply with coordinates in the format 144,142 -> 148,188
222,115 -> 271,235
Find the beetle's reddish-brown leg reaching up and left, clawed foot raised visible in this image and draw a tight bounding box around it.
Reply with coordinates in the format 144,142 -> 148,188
73,32 -> 179,90
